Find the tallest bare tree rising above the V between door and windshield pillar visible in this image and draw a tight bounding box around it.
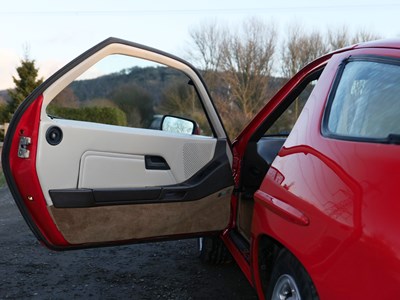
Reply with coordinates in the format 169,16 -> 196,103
221,19 -> 276,129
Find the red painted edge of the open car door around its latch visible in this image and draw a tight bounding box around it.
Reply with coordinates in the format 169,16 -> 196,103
9,96 -> 68,246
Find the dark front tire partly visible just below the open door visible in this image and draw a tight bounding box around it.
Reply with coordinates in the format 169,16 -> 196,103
197,236 -> 232,265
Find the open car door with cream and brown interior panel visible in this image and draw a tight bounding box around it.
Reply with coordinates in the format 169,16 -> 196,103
2,38 -> 233,250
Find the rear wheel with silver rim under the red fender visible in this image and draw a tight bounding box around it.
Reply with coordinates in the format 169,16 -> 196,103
266,249 -> 319,300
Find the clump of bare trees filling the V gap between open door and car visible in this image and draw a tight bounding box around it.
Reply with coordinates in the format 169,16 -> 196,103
190,19 -> 276,137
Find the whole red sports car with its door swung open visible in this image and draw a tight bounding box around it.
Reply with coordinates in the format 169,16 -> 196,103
2,38 -> 400,299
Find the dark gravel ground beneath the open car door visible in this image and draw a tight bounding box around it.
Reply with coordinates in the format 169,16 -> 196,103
0,188 -> 257,299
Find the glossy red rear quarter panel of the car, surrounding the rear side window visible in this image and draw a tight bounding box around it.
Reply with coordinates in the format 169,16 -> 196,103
253,48 -> 400,299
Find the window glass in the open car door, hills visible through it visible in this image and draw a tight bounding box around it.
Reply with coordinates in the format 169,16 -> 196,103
47,55 -> 212,136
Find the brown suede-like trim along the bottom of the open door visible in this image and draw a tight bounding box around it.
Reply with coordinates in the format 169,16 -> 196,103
49,187 -> 232,244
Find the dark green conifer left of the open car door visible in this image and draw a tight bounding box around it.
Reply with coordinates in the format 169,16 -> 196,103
8,54 -> 43,118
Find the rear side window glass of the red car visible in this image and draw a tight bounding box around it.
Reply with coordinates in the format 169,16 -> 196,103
324,58 -> 400,142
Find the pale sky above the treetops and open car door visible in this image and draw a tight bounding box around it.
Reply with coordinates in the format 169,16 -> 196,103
0,0 -> 400,90
